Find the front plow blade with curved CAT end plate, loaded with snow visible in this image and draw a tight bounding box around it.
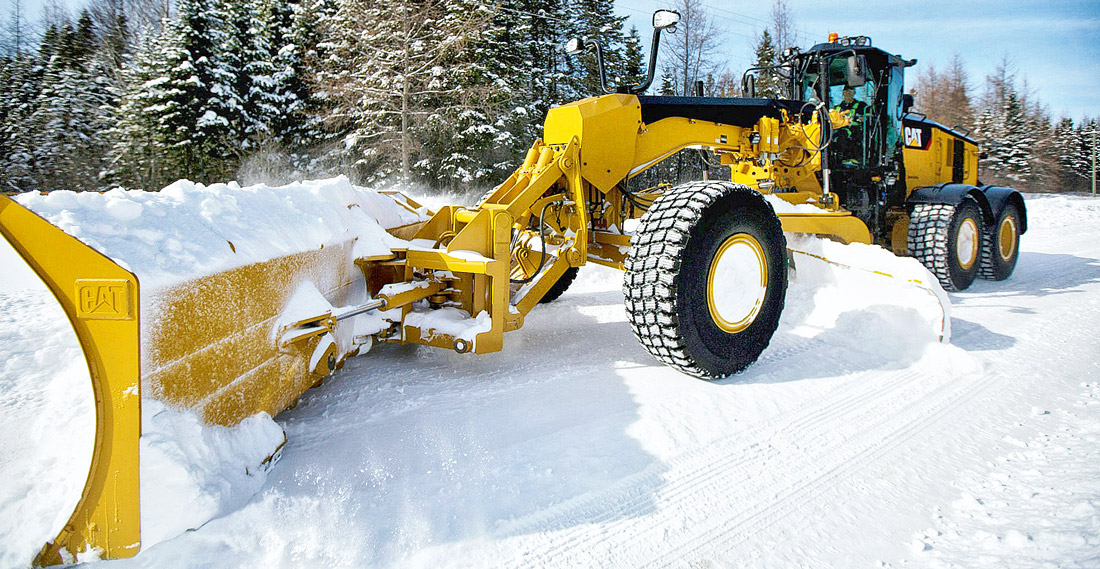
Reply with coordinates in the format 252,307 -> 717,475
0,180 -> 426,566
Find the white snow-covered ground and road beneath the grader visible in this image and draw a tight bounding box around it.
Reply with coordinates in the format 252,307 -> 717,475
0,188 -> 1100,568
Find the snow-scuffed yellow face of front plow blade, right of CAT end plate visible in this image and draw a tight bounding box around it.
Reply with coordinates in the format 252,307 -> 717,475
142,241 -> 362,427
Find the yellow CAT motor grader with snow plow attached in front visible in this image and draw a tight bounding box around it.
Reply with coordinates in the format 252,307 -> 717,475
0,10 -> 1026,565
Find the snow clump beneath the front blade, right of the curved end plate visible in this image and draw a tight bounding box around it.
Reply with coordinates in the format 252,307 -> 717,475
141,398 -> 285,548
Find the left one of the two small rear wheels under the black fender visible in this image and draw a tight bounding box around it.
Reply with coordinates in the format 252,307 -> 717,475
906,198 -> 982,291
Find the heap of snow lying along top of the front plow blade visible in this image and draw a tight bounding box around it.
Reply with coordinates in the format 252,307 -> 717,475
18,177 -> 426,287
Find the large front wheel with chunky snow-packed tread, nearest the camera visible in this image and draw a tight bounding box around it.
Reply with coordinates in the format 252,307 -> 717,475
623,182 -> 787,379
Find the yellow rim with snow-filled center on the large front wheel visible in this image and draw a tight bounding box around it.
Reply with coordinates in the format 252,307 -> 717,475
706,233 -> 768,333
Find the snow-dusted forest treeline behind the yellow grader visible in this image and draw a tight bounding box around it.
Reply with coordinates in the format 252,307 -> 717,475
0,0 -> 1097,192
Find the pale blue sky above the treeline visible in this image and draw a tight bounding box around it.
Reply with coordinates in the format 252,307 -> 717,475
616,0 -> 1100,120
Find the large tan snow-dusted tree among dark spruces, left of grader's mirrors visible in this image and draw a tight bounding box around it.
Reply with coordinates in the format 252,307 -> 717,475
325,0 -> 486,184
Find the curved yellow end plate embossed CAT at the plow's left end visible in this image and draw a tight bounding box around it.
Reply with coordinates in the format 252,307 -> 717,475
0,196 -> 141,566
